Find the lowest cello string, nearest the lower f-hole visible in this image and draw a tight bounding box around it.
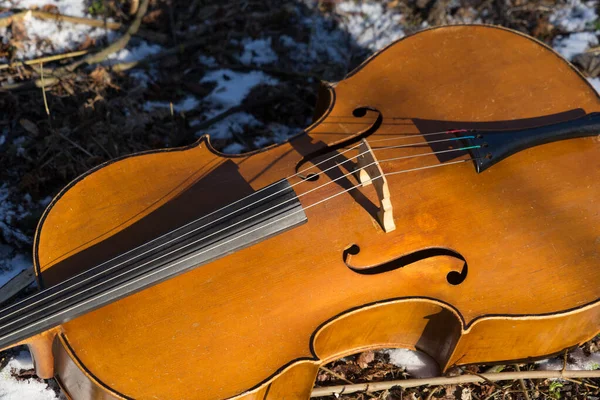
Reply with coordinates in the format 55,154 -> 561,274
0,158 -> 475,341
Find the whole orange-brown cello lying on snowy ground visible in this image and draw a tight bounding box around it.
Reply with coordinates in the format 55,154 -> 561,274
0,26 -> 600,400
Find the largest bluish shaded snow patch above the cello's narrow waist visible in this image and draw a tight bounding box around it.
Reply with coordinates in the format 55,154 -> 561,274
200,69 -> 279,118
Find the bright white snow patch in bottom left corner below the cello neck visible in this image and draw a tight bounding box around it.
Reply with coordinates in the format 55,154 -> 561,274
0,351 -> 59,400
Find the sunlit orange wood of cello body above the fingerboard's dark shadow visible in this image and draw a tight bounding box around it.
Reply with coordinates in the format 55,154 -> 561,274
34,138 -> 223,282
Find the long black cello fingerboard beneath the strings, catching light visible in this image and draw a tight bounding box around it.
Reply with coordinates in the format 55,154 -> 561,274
0,179 -> 307,348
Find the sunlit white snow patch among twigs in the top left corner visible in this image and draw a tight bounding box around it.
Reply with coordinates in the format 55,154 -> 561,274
0,12 -> 116,60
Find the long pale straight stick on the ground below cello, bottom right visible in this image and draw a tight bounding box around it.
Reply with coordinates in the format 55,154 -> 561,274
310,370 -> 600,397
